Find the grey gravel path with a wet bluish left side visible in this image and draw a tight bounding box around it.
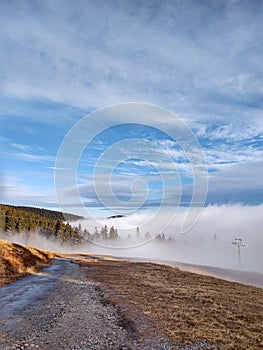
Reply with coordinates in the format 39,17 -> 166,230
0,259 -> 179,350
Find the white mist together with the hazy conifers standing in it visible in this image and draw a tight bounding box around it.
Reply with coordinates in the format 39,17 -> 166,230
0,205 -> 263,272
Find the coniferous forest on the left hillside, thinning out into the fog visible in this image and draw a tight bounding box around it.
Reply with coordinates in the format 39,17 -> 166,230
0,204 -> 172,247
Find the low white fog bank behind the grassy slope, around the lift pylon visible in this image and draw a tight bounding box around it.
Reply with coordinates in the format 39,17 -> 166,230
2,205 -> 263,273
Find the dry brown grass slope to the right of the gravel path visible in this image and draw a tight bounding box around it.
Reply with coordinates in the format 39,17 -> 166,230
79,259 -> 263,350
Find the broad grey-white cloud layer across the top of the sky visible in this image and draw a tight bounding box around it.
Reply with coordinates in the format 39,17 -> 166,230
1,2 -> 262,117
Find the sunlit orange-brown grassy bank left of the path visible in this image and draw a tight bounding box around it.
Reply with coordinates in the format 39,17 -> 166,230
0,240 -> 54,287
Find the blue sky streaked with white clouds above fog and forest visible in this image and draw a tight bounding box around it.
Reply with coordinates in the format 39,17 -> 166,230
0,0 -> 263,215
